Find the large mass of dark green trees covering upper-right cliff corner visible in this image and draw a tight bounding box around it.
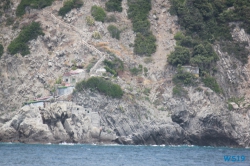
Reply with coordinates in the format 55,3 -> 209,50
168,0 -> 250,93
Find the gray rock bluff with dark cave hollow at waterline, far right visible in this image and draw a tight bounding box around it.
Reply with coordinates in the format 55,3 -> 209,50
172,104 -> 250,147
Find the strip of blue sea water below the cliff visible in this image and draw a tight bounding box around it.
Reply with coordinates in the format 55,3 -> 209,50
0,143 -> 250,166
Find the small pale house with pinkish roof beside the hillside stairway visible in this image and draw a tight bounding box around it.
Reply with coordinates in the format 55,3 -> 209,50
63,69 -> 85,86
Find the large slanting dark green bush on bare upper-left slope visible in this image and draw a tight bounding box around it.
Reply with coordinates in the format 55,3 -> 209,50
7,22 -> 44,56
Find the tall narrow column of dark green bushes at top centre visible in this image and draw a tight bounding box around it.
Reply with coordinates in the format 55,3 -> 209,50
128,0 -> 156,56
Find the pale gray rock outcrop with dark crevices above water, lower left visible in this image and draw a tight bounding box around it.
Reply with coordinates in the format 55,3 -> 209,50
0,102 -> 115,143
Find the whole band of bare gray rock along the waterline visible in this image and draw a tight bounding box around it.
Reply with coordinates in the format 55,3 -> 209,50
0,91 -> 250,147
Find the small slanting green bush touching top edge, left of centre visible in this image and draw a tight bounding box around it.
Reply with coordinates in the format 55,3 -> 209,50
58,0 -> 83,17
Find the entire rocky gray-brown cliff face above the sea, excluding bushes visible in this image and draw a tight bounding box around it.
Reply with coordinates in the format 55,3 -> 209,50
0,0 -> 250,147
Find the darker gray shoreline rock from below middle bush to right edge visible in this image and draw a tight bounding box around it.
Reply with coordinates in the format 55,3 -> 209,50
74,91 -> 250,147
